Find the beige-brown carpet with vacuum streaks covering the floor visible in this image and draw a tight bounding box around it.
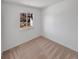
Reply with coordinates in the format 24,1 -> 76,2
2,36 -> 78,59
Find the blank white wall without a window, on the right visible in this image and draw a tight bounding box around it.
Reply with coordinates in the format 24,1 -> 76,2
42,0 -> 78,51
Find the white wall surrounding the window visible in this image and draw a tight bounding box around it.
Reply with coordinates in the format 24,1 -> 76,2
2,2 -> 41,51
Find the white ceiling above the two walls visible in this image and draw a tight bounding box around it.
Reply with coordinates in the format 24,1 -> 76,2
4,0 -> 62,8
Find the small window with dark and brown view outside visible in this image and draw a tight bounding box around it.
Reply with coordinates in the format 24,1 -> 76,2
20,13 -> 33,29
